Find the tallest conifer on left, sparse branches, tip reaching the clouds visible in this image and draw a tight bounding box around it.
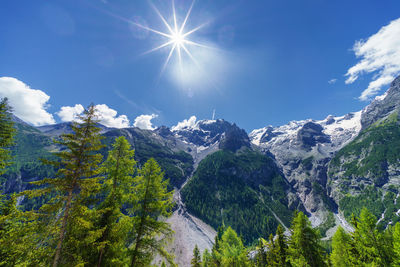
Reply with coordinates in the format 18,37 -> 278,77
26,105 -> 103,267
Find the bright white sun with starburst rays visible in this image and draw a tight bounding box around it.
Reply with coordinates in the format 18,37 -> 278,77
131,0 -> 212,77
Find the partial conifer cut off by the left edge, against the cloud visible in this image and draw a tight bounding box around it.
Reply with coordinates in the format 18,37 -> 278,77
0,98 -> 15,175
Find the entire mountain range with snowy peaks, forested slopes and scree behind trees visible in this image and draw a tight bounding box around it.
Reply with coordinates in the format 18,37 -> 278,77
1,77 -> 400,266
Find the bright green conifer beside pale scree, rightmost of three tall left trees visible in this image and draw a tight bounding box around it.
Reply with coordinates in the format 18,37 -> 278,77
130,158 -> 173,267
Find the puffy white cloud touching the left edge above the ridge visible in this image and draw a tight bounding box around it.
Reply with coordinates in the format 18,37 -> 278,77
0,77 -> 55,126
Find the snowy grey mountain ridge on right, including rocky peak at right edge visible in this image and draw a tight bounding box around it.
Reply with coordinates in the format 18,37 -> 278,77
249,77 -> 400,228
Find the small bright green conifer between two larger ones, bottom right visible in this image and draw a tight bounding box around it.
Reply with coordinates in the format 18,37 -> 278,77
330,226 -> 353,267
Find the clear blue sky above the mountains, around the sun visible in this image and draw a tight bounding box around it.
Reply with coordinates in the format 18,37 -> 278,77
0,0 -> 400,131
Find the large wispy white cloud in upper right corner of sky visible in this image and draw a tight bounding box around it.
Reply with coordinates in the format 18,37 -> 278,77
346,18 -> 400,101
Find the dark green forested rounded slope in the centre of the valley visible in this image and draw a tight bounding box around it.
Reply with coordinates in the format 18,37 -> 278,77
181,150 -> 291,244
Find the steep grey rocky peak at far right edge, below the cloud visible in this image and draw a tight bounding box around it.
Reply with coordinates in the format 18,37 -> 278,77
361,76 -> 400,129
